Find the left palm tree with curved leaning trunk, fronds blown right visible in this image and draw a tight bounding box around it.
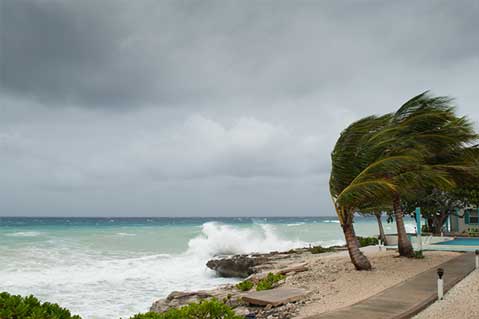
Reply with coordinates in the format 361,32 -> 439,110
329,114 -> 418,270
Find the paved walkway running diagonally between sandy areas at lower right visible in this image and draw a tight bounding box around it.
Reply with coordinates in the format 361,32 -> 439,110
307,253 -> 475,319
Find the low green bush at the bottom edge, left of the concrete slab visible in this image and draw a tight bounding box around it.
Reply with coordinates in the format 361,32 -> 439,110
130,299 -> 242,319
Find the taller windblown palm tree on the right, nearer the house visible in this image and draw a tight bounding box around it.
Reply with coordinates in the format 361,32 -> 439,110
372,92 -> 477,256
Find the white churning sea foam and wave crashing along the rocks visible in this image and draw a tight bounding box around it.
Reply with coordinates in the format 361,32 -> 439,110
0,222 -> 307,319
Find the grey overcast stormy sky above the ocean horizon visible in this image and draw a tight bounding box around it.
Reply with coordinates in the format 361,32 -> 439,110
0,0 -> 479,216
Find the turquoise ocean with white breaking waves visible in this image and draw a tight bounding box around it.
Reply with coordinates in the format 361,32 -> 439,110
0,217 -> 414,319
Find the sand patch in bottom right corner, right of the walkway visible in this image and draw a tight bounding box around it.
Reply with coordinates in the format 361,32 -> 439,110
413,270 -> 479,319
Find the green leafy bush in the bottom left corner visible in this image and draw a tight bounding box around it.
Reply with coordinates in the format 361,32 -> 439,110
0,292 -> 81,319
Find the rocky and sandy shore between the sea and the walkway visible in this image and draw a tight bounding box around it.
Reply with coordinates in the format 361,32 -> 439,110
150,250 -> 457,319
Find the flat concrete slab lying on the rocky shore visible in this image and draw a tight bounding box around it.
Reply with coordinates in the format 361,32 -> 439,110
243,288 -> 308,307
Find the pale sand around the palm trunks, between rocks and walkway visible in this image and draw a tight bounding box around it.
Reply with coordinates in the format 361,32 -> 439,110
285,247 -> 462,318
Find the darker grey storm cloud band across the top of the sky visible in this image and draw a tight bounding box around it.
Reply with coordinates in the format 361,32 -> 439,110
1,0 -> 479,107
